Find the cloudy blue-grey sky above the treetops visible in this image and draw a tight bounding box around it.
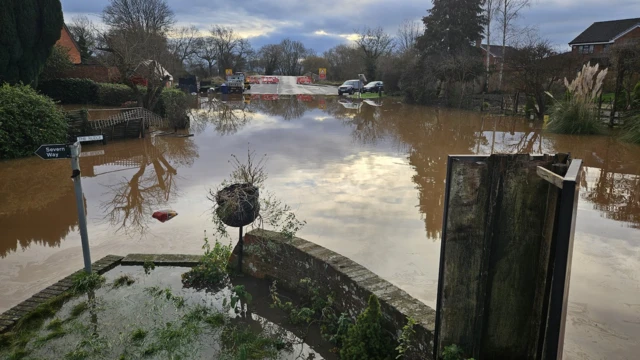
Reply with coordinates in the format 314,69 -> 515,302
61,0 -> 640,52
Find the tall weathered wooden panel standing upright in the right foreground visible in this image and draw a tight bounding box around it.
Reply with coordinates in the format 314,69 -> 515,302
434,154 -> 582,360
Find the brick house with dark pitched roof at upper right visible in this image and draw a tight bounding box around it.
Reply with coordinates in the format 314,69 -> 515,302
569,18 -> 640,58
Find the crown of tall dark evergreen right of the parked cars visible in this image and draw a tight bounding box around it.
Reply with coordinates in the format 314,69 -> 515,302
418,0 -> 487,54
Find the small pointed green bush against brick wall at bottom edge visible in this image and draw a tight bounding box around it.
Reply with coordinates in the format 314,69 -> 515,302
340,295 -> 396,360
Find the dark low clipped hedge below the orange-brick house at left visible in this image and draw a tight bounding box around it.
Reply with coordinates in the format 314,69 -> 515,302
38,79 -> 98,104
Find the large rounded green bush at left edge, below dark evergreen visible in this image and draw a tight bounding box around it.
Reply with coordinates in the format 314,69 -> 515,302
0,84 -> 67,159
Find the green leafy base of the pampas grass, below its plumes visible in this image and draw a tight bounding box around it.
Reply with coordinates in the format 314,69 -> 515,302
547,100 -> 604,135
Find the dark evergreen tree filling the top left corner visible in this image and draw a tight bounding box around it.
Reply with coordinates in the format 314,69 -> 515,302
0,0 -> 64,85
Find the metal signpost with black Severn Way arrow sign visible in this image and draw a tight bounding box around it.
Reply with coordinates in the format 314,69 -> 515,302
35,142 -> 92,274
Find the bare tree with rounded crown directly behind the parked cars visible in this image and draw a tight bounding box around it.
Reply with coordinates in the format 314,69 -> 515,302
356,27 -> 394,80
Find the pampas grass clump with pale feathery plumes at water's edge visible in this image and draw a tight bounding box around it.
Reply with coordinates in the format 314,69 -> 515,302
548,64 -> 607,135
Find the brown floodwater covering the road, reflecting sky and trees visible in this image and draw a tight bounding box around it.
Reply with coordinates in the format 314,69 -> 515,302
0,95 -> 640,359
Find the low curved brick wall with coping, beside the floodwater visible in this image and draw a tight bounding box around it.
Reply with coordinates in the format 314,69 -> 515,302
232,229 -> 435,359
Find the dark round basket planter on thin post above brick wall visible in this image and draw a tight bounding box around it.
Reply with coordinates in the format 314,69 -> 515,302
216,184 -> 260,227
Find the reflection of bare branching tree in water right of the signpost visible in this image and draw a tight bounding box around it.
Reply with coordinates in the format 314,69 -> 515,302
100,136 -> 198,235
